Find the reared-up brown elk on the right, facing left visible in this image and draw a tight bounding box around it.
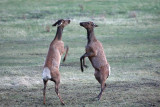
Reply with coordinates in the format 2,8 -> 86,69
80,22 -> 110,100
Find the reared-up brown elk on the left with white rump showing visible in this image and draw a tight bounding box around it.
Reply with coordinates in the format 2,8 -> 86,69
42,19 -> 70,105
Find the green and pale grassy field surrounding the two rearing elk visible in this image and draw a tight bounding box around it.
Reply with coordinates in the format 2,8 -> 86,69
0,0 -> 160,107
